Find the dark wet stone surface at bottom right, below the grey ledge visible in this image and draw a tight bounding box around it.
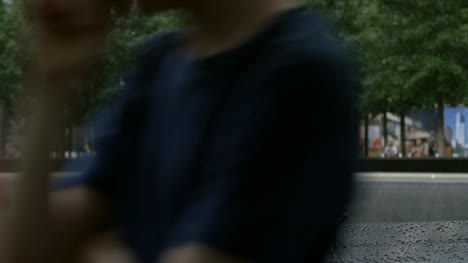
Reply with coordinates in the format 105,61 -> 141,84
327,221 -> 468,263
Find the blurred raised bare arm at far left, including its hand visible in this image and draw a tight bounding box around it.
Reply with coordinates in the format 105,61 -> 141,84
0,0 -> 130,263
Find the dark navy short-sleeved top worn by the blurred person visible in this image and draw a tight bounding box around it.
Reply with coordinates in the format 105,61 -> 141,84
77,10 -> 358,263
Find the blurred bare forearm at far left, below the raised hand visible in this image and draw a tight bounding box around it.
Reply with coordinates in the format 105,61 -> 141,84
0,94 -> 111,263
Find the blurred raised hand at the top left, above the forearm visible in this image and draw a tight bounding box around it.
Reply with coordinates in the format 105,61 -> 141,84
25,0 -> 130,88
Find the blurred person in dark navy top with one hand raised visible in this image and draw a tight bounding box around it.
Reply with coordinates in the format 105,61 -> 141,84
0,0 -> 357,263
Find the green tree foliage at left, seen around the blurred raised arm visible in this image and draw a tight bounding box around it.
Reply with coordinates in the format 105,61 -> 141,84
0,5 -> 185,154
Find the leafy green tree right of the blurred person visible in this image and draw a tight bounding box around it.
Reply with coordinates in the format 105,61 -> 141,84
350,0 -> 468,156
